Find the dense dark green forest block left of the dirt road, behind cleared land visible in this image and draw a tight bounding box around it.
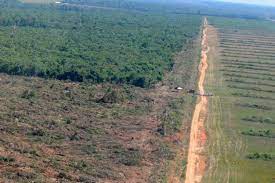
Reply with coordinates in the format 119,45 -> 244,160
0,1 -> 201,87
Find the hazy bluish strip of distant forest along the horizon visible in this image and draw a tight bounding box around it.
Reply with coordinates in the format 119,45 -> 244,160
62,0 -> 275,19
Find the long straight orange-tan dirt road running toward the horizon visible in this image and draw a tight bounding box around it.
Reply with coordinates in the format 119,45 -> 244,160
185,19 -> 210,183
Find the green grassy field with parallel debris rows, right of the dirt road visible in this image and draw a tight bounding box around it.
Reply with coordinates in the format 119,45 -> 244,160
204,17 -> 275,183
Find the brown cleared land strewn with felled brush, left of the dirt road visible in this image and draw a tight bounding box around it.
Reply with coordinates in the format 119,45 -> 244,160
0,27 -> 199,183
